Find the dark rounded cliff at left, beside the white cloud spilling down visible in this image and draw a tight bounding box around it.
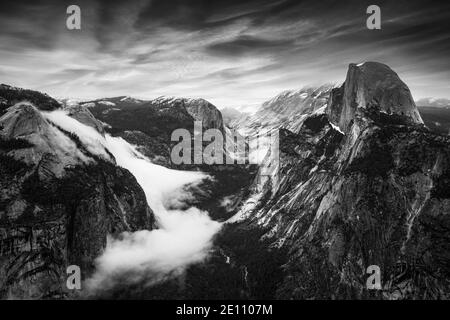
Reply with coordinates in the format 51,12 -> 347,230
0,99 -> 153,299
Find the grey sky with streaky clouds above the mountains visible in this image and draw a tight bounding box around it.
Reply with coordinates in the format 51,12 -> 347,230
0,0 -> 450,110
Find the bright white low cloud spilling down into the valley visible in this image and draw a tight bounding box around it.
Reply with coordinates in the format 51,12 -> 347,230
47,111 -> 221,292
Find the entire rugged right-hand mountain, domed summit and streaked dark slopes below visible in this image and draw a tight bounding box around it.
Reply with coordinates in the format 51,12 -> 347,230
236,64 -> 450,299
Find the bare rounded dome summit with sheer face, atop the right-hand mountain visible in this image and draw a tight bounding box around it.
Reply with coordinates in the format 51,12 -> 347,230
327,62 -> 423,131
